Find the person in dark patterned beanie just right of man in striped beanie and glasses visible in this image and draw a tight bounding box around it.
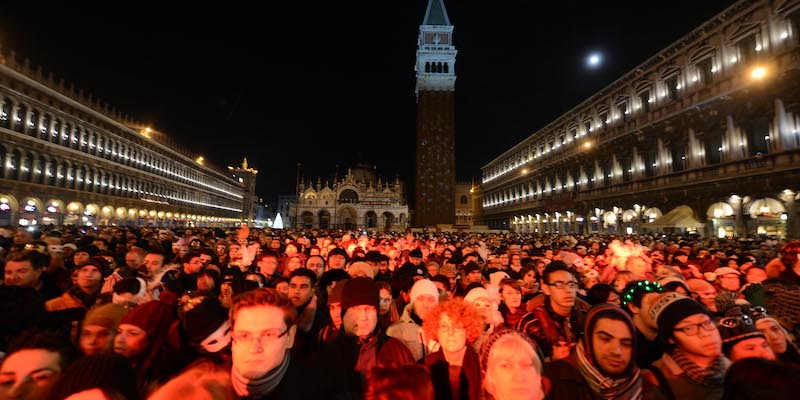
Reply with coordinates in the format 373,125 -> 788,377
716,306 -> 776,362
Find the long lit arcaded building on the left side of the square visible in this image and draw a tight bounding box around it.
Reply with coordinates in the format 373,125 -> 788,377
0,51 -> 257,226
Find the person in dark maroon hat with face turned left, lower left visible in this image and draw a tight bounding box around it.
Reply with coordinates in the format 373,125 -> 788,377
114,299 -> 175,392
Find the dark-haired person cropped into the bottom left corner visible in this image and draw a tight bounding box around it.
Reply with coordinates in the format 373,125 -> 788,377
0,331 -> 76,400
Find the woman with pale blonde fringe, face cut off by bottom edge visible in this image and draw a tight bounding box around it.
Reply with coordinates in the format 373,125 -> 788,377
479,329 -> 544,400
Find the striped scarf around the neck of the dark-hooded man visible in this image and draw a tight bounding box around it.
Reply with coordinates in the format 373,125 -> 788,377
575,341 -> 642,400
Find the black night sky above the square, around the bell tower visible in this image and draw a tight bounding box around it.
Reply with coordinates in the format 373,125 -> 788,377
0,0 -> 732,205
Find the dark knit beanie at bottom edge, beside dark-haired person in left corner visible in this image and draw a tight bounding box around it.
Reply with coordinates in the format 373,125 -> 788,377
50,354 -> 139,399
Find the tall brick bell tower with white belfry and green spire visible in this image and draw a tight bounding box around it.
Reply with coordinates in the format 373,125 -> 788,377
413,0 -> 457,227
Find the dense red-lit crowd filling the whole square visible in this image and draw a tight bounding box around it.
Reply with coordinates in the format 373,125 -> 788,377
0,226 -> 800,400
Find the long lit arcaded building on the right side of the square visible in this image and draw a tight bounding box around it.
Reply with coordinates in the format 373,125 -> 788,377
473,0 -> 800,237
